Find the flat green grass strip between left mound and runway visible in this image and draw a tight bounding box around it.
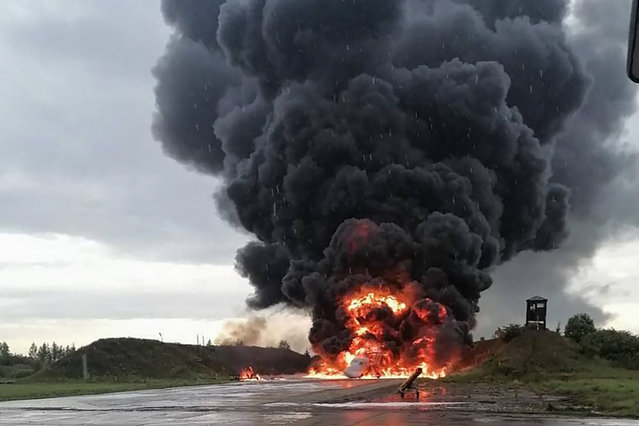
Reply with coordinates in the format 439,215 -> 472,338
0,379 -> 227,401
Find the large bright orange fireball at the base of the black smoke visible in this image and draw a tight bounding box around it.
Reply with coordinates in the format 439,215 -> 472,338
309,285 -> 448,379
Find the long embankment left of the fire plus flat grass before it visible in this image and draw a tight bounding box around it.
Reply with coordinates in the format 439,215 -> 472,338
0,338 -> 311,401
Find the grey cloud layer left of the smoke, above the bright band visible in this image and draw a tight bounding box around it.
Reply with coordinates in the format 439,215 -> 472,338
0,1 -> 246,264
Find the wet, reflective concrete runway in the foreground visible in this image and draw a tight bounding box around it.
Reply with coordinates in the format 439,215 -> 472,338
0,380 -> 639,426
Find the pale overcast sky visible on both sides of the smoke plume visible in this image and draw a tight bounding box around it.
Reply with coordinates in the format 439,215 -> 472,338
0,0 -> 639,352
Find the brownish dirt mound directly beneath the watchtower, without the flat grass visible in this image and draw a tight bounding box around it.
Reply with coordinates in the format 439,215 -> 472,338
459,330 -> 598,378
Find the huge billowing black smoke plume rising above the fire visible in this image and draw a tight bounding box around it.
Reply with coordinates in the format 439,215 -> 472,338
154,0 -> 634,353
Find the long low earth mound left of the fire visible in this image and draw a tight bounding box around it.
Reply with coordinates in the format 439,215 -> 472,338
32,338 -> 310,380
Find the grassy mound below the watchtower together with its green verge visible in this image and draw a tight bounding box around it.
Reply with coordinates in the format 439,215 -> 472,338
442,332 -> 639,418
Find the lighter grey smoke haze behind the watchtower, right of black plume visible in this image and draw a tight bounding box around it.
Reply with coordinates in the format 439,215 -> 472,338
479,0 -> 639,334
